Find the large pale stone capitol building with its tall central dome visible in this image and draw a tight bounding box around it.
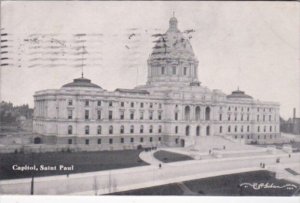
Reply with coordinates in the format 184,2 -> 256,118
33,17 -> 280,150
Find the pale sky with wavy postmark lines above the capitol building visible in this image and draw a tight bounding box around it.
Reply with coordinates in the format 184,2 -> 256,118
0,1 -> 300,118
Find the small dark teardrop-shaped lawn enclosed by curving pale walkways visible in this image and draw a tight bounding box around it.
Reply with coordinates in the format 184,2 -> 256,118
153,150 -> 193,163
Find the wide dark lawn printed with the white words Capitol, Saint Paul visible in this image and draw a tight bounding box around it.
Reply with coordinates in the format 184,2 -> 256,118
0,150 -> 147,180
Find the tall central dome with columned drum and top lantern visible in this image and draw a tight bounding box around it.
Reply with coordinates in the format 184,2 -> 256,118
147,17 -> 199,86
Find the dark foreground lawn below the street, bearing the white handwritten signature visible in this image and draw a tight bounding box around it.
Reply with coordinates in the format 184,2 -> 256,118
114,171 -> 299,196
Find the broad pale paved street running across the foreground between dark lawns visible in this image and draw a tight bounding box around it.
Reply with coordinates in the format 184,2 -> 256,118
0,153 -> 300,195
